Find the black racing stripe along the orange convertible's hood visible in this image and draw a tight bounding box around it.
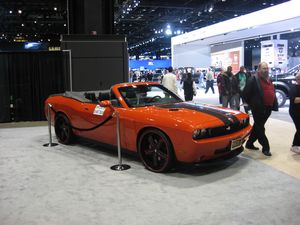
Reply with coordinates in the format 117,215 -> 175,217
157,102 -> 239,126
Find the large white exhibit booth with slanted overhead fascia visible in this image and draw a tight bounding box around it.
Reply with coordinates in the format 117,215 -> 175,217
171,0 -> 300,71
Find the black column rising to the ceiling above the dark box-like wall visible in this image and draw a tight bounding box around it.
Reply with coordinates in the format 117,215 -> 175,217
68,0 -> 114,35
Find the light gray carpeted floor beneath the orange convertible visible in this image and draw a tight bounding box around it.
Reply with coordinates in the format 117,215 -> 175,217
0,126 -> 300,225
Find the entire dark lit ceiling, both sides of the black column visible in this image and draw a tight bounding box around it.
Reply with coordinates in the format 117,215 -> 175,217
0,0 -> 287,55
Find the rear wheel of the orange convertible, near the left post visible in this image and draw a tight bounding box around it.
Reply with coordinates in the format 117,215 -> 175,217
54,114 -> 74,145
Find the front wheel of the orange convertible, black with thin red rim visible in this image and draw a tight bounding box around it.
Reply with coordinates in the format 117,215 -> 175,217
138,129 -> 175,173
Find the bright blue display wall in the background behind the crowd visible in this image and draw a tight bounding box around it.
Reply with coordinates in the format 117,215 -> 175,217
129,59 -> 171,70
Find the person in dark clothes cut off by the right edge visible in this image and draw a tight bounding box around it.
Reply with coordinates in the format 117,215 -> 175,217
289,72 -> 300,153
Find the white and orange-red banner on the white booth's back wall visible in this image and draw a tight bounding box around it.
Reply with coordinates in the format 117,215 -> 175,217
211,47 -> 242,73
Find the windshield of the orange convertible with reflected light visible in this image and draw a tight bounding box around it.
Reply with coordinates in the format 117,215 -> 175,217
119,85 -> 182,107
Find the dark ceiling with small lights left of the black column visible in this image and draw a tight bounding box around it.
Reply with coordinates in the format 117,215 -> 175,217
0,0 -> 67,45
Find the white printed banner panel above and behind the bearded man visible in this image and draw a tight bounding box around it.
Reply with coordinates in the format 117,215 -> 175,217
261,40 -> 288,71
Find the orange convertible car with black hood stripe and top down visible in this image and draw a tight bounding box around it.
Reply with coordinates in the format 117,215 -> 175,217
45,82 -> 251,172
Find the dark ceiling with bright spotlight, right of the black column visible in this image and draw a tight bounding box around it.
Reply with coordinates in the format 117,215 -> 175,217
115,0 -> 286,55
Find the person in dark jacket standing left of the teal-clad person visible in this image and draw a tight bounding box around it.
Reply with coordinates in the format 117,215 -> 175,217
220,66 -> 240,110
